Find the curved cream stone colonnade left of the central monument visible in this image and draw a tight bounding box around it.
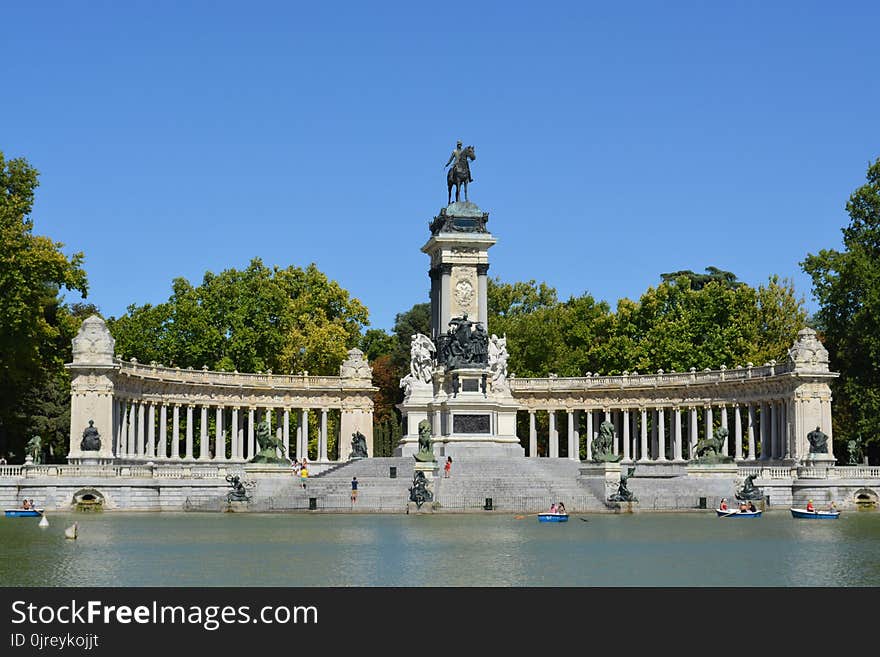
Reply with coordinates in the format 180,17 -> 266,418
67,316 -> 376,463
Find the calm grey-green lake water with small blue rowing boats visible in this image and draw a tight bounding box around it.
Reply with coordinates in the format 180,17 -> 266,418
0,510 -> 880,587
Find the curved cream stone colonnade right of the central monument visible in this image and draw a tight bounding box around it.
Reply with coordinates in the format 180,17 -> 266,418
509,328 -> 837,463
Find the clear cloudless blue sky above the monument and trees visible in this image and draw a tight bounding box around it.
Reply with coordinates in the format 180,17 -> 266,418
0,0 -> 880,330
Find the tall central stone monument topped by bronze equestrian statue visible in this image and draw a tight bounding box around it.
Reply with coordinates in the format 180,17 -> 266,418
396,142 -> 525,458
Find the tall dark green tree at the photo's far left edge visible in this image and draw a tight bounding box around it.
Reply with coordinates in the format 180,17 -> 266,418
0,152 -> 88,457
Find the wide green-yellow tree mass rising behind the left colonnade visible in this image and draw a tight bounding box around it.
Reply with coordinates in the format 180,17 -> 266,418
108,258 -> 367,375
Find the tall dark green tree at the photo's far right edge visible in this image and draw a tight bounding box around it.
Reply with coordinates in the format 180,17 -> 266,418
801,158 -> 880,456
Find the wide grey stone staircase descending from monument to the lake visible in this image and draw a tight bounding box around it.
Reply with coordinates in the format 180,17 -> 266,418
249,456 -> 607,513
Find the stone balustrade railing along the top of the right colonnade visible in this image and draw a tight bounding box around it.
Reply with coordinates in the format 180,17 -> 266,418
508,362 -> 795,393
